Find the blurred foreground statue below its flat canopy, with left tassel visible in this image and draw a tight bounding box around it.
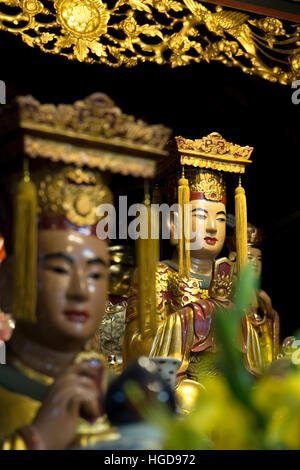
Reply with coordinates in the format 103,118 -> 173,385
0,162 -> 121,449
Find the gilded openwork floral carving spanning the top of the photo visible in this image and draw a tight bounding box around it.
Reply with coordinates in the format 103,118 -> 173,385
0,0 -> 300,84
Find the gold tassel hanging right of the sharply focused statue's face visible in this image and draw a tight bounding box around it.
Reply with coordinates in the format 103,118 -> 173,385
235,177 -> 248,273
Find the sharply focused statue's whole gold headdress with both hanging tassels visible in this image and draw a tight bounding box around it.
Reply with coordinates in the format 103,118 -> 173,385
176,132 -> 253,277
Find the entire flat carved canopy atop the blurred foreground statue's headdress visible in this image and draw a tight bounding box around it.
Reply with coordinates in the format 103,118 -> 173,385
0,93 -> 172,178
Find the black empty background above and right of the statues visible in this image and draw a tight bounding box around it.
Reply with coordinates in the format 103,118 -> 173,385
0,32 -> 300,338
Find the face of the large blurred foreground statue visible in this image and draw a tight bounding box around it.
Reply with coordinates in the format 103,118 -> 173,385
37,230 -> 109,342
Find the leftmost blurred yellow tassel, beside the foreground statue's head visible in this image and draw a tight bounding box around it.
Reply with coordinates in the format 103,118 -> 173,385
13,162 -> 37,323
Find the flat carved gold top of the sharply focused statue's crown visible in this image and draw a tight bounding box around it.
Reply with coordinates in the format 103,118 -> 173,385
176,132 -> 254,173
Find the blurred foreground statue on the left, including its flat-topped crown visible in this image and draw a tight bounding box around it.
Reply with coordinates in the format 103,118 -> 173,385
0,94 -> 169,449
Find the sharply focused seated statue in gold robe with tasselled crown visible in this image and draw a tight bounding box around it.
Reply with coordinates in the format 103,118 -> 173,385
124,133 -> 253,406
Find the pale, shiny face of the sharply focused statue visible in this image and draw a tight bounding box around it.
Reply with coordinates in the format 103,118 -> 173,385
191,199 -> 226,260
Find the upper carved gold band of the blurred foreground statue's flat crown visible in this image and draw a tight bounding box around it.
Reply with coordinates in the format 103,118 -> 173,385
0,93 -> 171,155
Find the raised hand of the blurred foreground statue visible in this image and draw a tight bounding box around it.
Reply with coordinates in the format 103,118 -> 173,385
27,363 -> 100,450
